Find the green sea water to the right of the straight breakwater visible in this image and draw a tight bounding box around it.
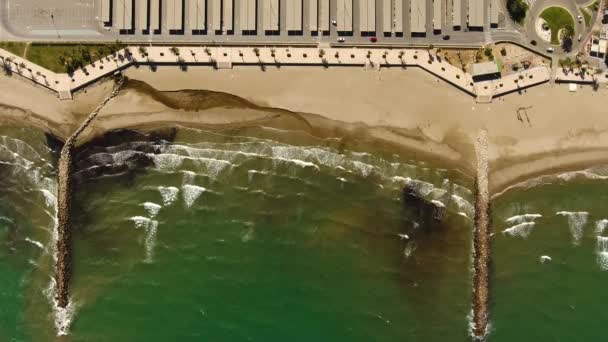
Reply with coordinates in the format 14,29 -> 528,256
490,175 -> 608,342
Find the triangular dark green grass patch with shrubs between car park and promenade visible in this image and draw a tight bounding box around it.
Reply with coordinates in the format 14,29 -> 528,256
26,43 -> 121,73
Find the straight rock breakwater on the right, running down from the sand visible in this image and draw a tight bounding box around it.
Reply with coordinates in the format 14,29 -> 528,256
472,130 -> 491,340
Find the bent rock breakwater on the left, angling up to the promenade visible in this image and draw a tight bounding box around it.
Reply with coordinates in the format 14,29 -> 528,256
55,77 -> 124,308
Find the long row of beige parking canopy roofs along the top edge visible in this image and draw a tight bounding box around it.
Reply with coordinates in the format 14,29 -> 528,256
99,0 -> 501,35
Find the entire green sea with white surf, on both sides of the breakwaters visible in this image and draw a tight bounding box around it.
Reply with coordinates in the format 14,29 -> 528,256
0,127 -> 608,341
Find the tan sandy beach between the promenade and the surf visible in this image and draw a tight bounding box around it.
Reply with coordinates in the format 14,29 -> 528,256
0,67 -> 608,193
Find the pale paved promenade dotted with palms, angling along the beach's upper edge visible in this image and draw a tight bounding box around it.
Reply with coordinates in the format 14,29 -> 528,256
0,46 -> 608,102
